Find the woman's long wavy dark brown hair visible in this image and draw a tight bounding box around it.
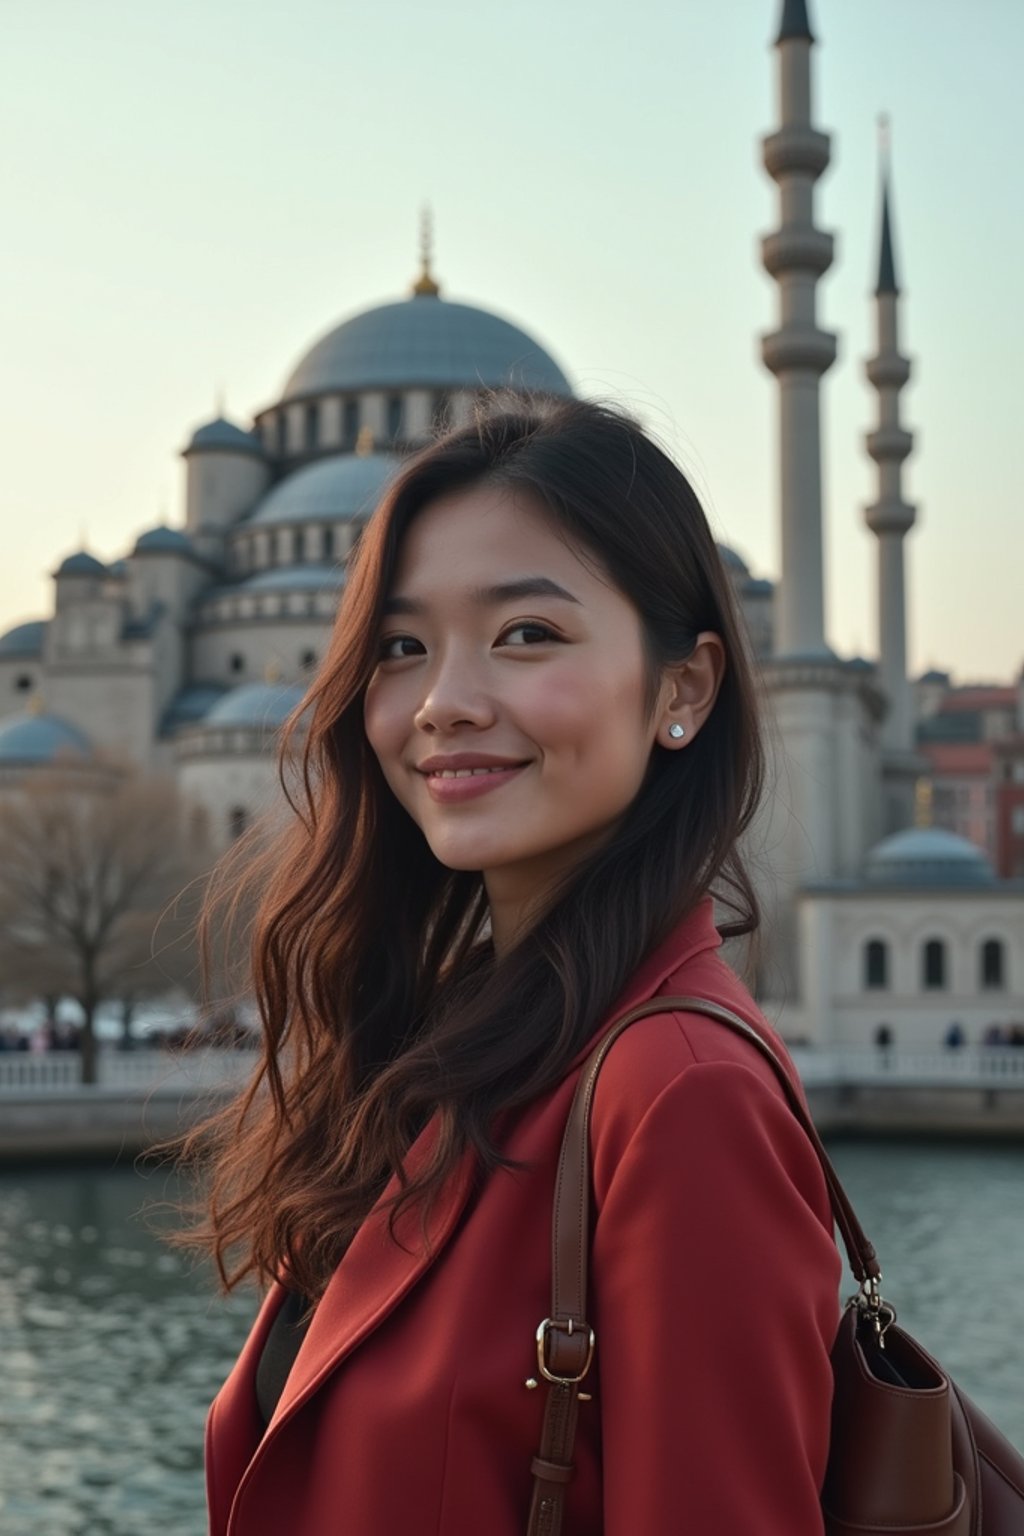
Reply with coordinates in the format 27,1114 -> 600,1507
170,401 -> 763,1299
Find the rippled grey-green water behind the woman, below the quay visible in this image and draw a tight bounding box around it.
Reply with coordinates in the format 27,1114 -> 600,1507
0,1143 -> 1024,1536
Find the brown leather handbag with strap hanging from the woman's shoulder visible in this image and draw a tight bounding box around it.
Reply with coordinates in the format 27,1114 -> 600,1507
528,997 -> 1024,1536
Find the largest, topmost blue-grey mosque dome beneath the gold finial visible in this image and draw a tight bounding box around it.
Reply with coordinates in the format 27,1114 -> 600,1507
281,293 -> 573,401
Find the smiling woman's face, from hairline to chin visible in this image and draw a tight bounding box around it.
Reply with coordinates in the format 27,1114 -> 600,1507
365,485 -> 693,927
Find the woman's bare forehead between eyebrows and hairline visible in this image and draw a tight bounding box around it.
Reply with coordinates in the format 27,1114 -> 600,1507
391,484 -> 608,598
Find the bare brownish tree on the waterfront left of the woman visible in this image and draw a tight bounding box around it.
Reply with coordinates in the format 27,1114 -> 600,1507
0,773 -> 210,1083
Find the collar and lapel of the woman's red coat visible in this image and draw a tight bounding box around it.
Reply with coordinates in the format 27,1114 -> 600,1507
215,897 -> 722,1511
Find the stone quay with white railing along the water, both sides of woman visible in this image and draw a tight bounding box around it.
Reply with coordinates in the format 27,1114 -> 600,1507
0,1046 -> 1024,1163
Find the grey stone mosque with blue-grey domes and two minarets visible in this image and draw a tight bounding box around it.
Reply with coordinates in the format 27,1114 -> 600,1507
0,0 -> 1024,1049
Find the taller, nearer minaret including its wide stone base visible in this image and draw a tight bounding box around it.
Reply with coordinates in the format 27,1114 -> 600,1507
749,0 -> 884,1040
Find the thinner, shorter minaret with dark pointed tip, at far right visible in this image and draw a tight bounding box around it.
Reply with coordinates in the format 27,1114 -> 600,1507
864,121 -> 915,756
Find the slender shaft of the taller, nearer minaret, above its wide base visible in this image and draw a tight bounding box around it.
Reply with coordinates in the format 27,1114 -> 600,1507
761,0 -> 835,656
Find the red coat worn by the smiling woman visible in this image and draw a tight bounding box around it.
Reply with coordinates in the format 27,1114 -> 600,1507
206,900 -> 840,1536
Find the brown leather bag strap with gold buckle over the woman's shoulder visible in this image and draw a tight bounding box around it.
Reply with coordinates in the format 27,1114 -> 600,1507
527,997 -> 881,1536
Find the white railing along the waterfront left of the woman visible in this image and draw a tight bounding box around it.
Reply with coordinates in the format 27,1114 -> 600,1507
0,1046 -> 255,1097
